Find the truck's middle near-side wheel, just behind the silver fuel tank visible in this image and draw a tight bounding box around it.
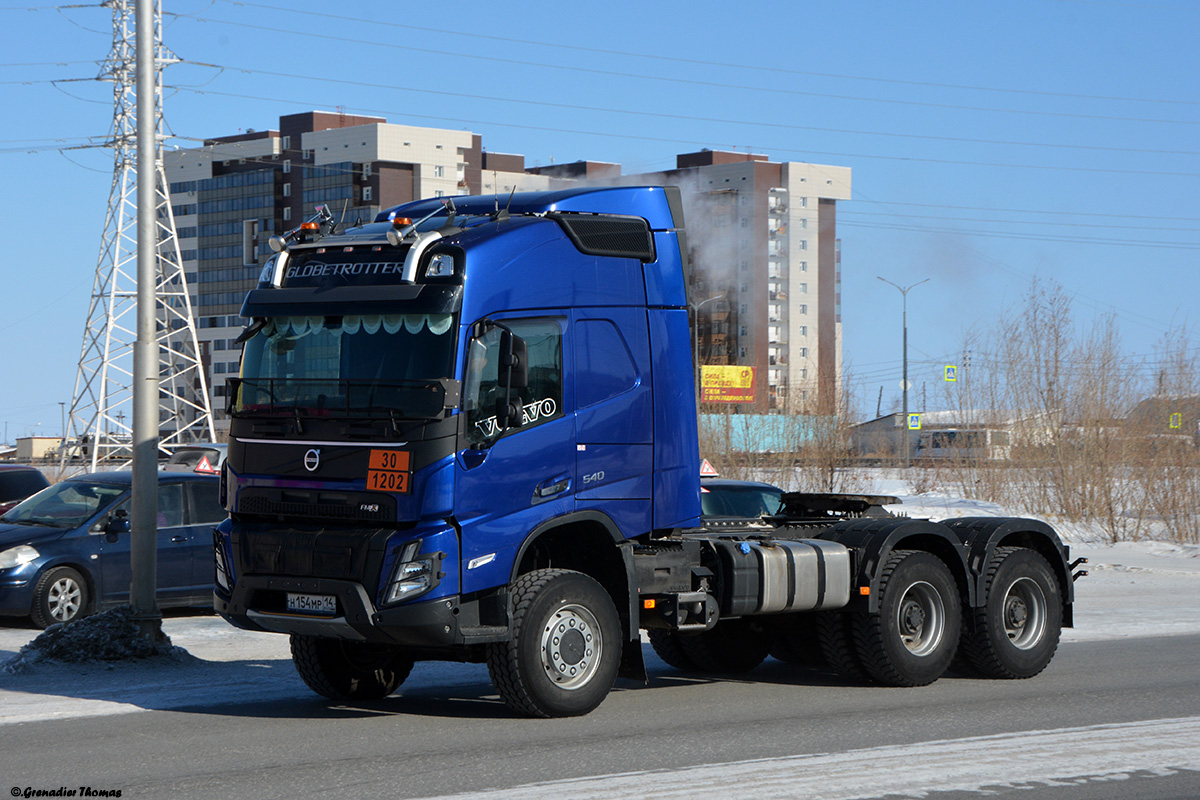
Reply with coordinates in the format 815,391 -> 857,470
853,551 -> 962,686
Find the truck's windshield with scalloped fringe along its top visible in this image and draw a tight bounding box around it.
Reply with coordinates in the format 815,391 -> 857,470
234,314 -> 455,419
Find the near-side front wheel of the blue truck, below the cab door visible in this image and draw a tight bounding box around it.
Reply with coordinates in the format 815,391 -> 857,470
487,570 -> 623,718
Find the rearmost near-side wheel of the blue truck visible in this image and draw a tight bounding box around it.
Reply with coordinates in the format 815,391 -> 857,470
961,547 -> 1062,678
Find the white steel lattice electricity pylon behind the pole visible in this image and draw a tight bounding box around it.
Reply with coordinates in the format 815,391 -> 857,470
62,0 -> 216,469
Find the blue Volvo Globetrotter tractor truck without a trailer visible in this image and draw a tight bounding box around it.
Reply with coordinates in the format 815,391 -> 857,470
214,187 -> 1079,717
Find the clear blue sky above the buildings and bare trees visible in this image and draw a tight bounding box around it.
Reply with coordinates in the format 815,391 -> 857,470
0,0 -> 1200,440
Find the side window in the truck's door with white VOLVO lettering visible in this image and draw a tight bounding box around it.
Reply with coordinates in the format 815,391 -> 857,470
463,318 -> 563,444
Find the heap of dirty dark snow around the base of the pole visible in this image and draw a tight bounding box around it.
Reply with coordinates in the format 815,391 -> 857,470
4,606 -> 191,674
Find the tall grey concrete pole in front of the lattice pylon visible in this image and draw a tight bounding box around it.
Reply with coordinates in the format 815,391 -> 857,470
130,0 -> 162,638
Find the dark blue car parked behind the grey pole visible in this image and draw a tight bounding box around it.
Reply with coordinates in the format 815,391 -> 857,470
0,471 -> 226,627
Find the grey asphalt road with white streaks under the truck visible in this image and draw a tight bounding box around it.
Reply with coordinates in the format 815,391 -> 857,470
0,636 -> 1200,800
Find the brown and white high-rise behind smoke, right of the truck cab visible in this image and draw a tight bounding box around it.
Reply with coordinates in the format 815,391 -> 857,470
619,150 -> 851,414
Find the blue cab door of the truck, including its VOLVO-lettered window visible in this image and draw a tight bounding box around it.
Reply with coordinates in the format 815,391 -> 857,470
455,314 -> 576,593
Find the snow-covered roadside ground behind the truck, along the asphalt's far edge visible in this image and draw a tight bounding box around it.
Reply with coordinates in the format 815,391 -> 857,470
0,489 -> 1200,726
